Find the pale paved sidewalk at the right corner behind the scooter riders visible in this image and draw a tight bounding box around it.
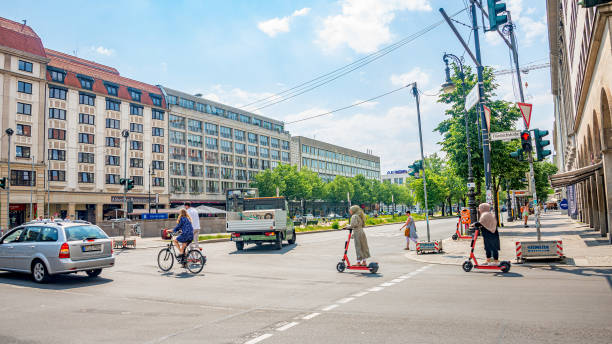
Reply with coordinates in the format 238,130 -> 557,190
406,212 -> 612,267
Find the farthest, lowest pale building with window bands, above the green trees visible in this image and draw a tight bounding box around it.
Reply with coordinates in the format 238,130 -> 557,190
291,136 -> 380,182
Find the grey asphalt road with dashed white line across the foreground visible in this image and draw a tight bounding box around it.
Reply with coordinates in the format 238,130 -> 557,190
0,219 -> 612,343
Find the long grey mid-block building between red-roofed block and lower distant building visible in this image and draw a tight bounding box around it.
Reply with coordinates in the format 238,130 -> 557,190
160,86 -> 291,205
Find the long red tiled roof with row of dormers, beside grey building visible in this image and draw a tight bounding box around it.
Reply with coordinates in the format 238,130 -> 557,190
45,49 -> 166,107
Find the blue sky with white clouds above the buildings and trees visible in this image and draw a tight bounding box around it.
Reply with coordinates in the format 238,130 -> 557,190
1,0 -> 554,174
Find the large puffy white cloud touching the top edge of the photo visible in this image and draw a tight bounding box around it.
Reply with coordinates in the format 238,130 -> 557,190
316,0 -> 431,53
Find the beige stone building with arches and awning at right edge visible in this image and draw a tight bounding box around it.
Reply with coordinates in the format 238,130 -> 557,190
547,0 -> 612,243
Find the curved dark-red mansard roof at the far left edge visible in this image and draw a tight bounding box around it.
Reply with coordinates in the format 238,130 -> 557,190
0,18 -> 47,57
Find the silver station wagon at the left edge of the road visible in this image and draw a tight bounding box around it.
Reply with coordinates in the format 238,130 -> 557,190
0,220 -> 115,283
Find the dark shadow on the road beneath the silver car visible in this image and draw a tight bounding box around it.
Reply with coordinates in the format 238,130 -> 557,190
0,272 -> 113,290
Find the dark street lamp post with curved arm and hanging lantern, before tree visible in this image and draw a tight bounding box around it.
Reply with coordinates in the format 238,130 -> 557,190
442,53 -> 478,223
